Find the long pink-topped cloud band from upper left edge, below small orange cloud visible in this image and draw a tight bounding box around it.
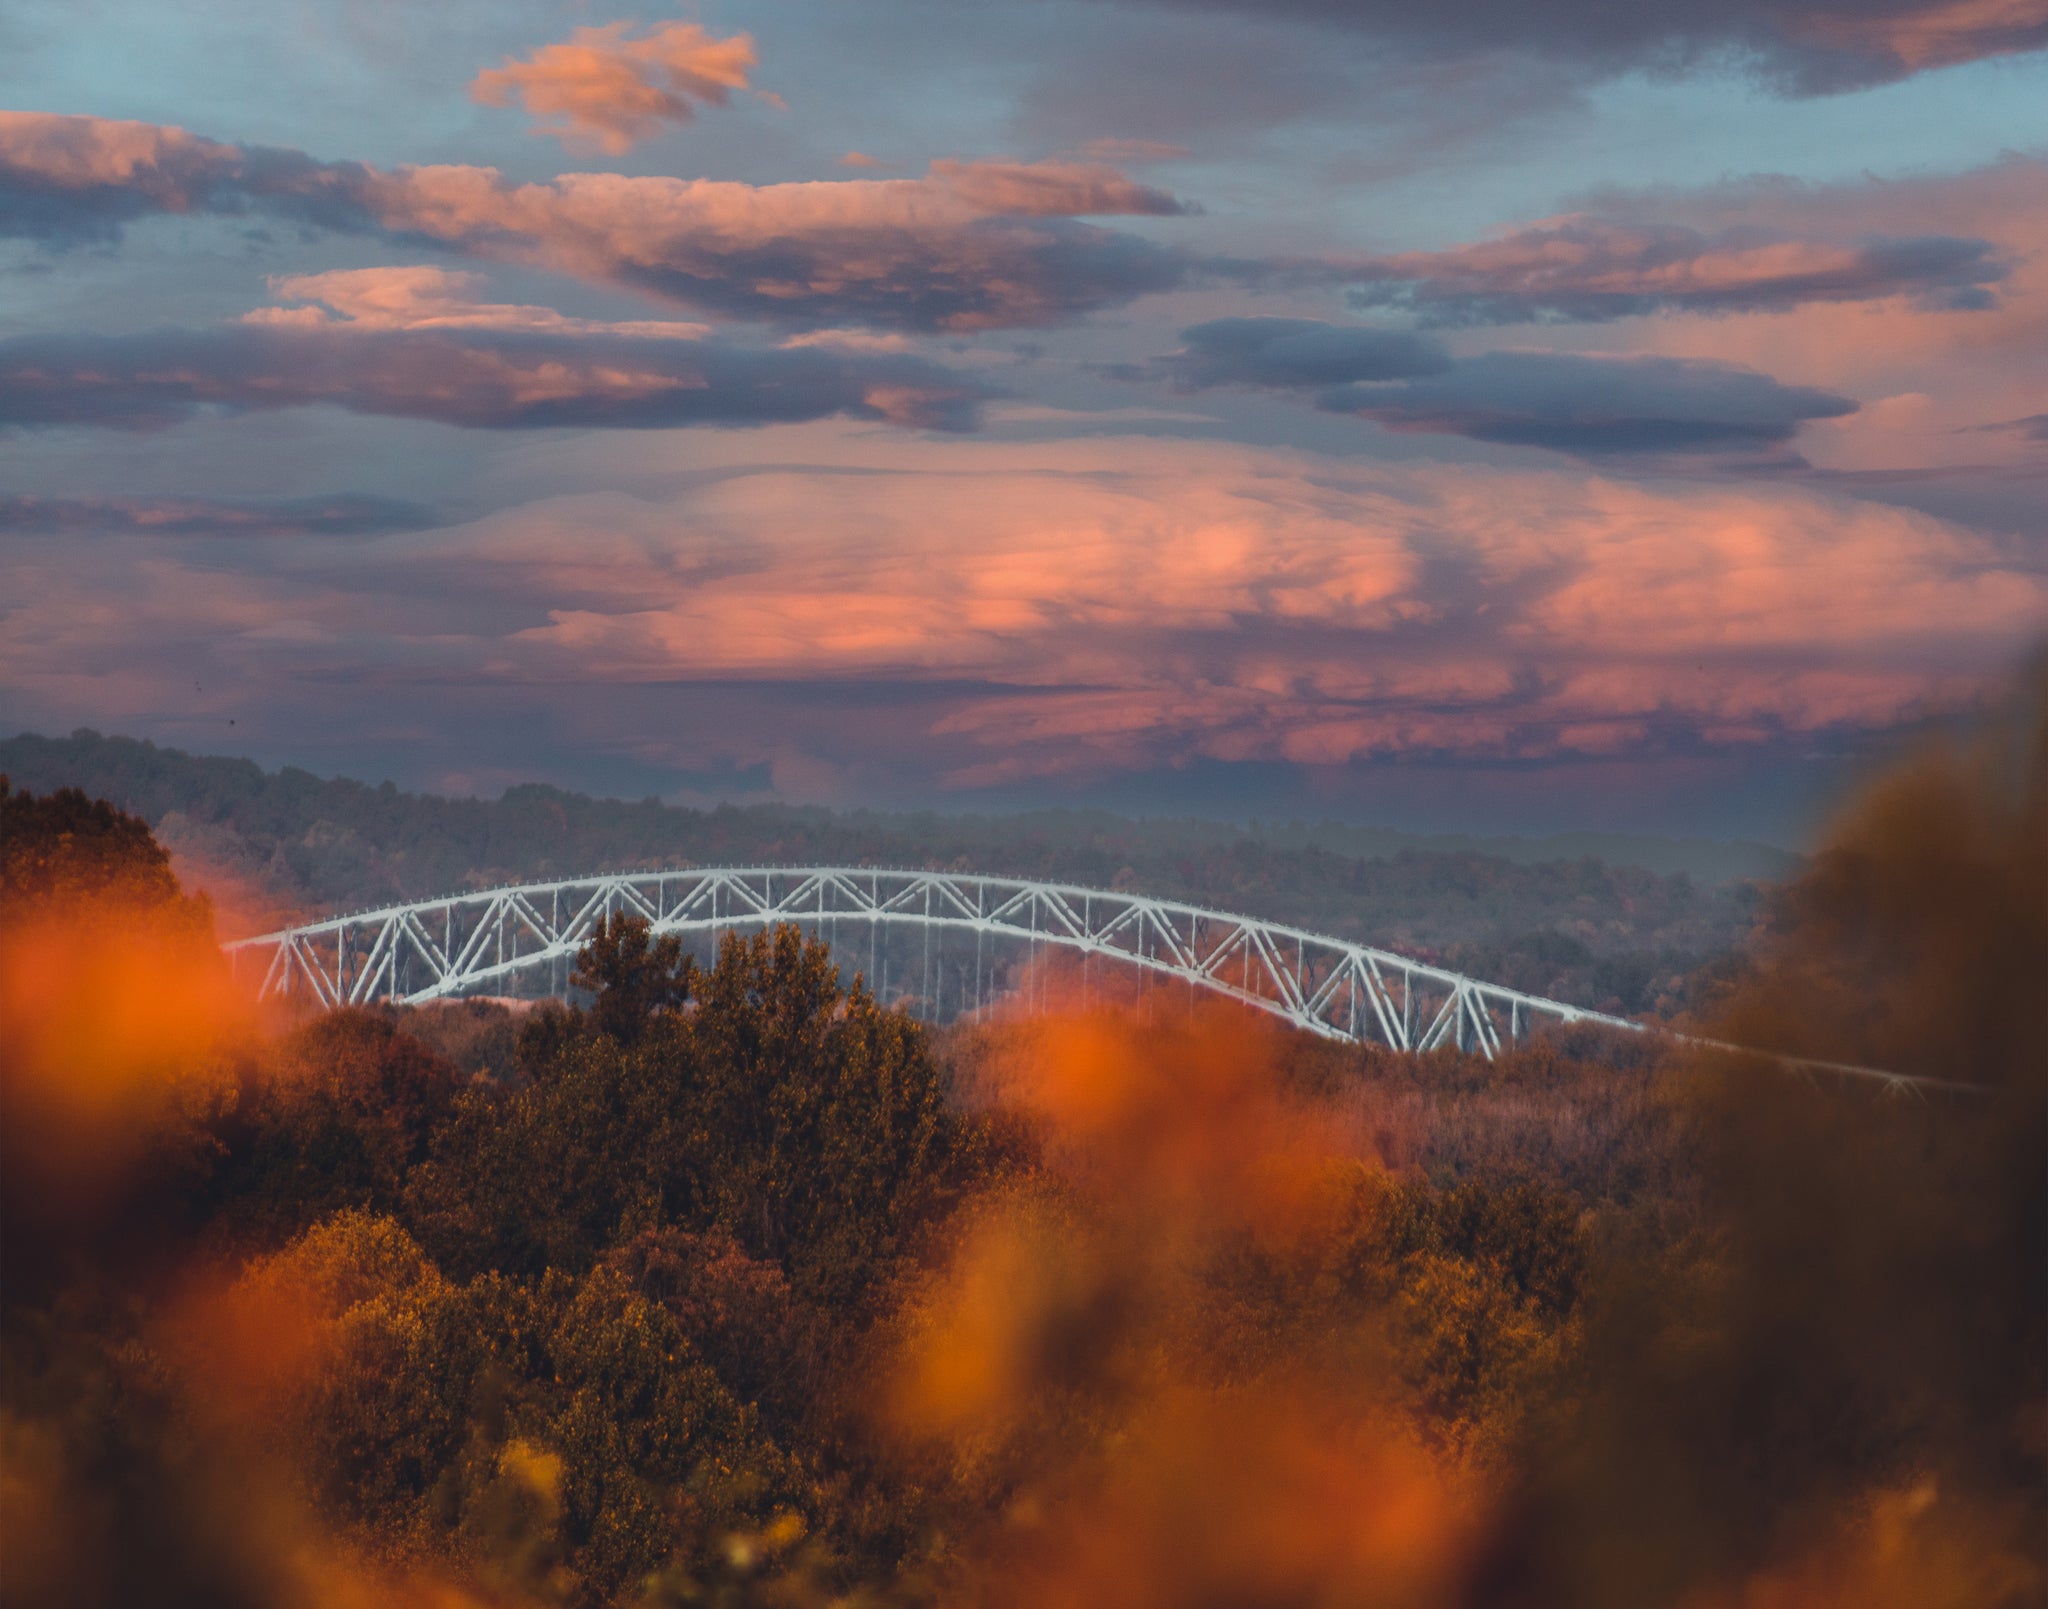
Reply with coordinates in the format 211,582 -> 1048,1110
0,113 -> 1190,330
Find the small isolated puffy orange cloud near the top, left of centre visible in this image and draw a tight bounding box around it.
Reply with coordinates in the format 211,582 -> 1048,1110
469,23 -> 756,156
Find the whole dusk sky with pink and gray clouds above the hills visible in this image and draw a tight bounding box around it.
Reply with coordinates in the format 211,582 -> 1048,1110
0,0 -> 2048,843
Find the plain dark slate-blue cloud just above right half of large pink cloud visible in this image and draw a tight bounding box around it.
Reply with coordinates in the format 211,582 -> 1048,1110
1155,319 -> 1855,454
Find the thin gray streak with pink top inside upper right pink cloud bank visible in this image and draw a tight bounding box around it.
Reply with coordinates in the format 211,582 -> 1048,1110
1350,217 -> 2009,325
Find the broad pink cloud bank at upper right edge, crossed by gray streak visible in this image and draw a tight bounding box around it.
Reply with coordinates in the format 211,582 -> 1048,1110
1310,156 -> 2048,473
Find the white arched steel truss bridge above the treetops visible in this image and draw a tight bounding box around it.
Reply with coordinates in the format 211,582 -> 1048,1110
227,866 -> 1640,1058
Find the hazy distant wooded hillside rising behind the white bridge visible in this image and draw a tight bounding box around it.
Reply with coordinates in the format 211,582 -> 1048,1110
0,733 -> 1796,1015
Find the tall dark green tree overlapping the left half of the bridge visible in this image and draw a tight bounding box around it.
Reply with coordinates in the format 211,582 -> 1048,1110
412,919 -> 985,1312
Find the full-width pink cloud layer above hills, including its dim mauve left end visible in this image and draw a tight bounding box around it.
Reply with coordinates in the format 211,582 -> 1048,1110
12,440 -> 2048,788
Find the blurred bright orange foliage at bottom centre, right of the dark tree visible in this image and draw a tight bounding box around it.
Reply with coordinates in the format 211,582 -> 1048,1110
893,1007 -> 1479,1607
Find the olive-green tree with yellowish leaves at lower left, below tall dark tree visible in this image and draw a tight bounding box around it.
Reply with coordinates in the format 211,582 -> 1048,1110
233,1212 -> 811,1605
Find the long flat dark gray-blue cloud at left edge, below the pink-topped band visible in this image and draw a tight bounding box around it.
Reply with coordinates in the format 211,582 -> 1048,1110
0,323 -> 989,430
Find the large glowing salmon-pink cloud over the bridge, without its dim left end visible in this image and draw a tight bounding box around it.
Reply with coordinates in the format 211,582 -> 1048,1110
467,442 -> 2048,768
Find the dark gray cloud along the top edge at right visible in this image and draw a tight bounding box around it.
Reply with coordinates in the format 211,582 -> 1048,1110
1114,0 -> 2048,94
